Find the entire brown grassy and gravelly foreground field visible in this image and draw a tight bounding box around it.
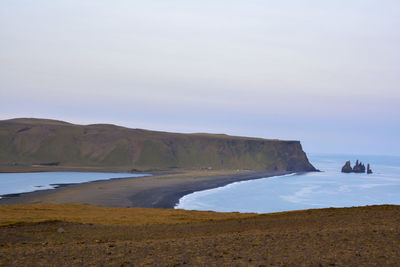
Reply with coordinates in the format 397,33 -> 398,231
0,204 -> 400,266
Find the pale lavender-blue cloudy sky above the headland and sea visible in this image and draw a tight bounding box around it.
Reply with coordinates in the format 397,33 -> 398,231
0,0 -> 400,155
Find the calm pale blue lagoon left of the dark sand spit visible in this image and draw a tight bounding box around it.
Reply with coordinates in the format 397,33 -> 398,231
0,172 -> 148,198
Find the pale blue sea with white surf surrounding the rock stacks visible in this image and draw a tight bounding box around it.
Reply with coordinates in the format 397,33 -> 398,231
175,155 -> 400,213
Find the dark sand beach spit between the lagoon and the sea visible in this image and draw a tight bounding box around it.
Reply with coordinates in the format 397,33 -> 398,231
0,170 -> 294,209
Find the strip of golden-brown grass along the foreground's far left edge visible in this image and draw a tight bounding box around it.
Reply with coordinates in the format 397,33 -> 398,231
0,203 -> 256,226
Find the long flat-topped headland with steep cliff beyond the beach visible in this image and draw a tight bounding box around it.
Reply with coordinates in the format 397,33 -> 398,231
0,119 -> 315,171
